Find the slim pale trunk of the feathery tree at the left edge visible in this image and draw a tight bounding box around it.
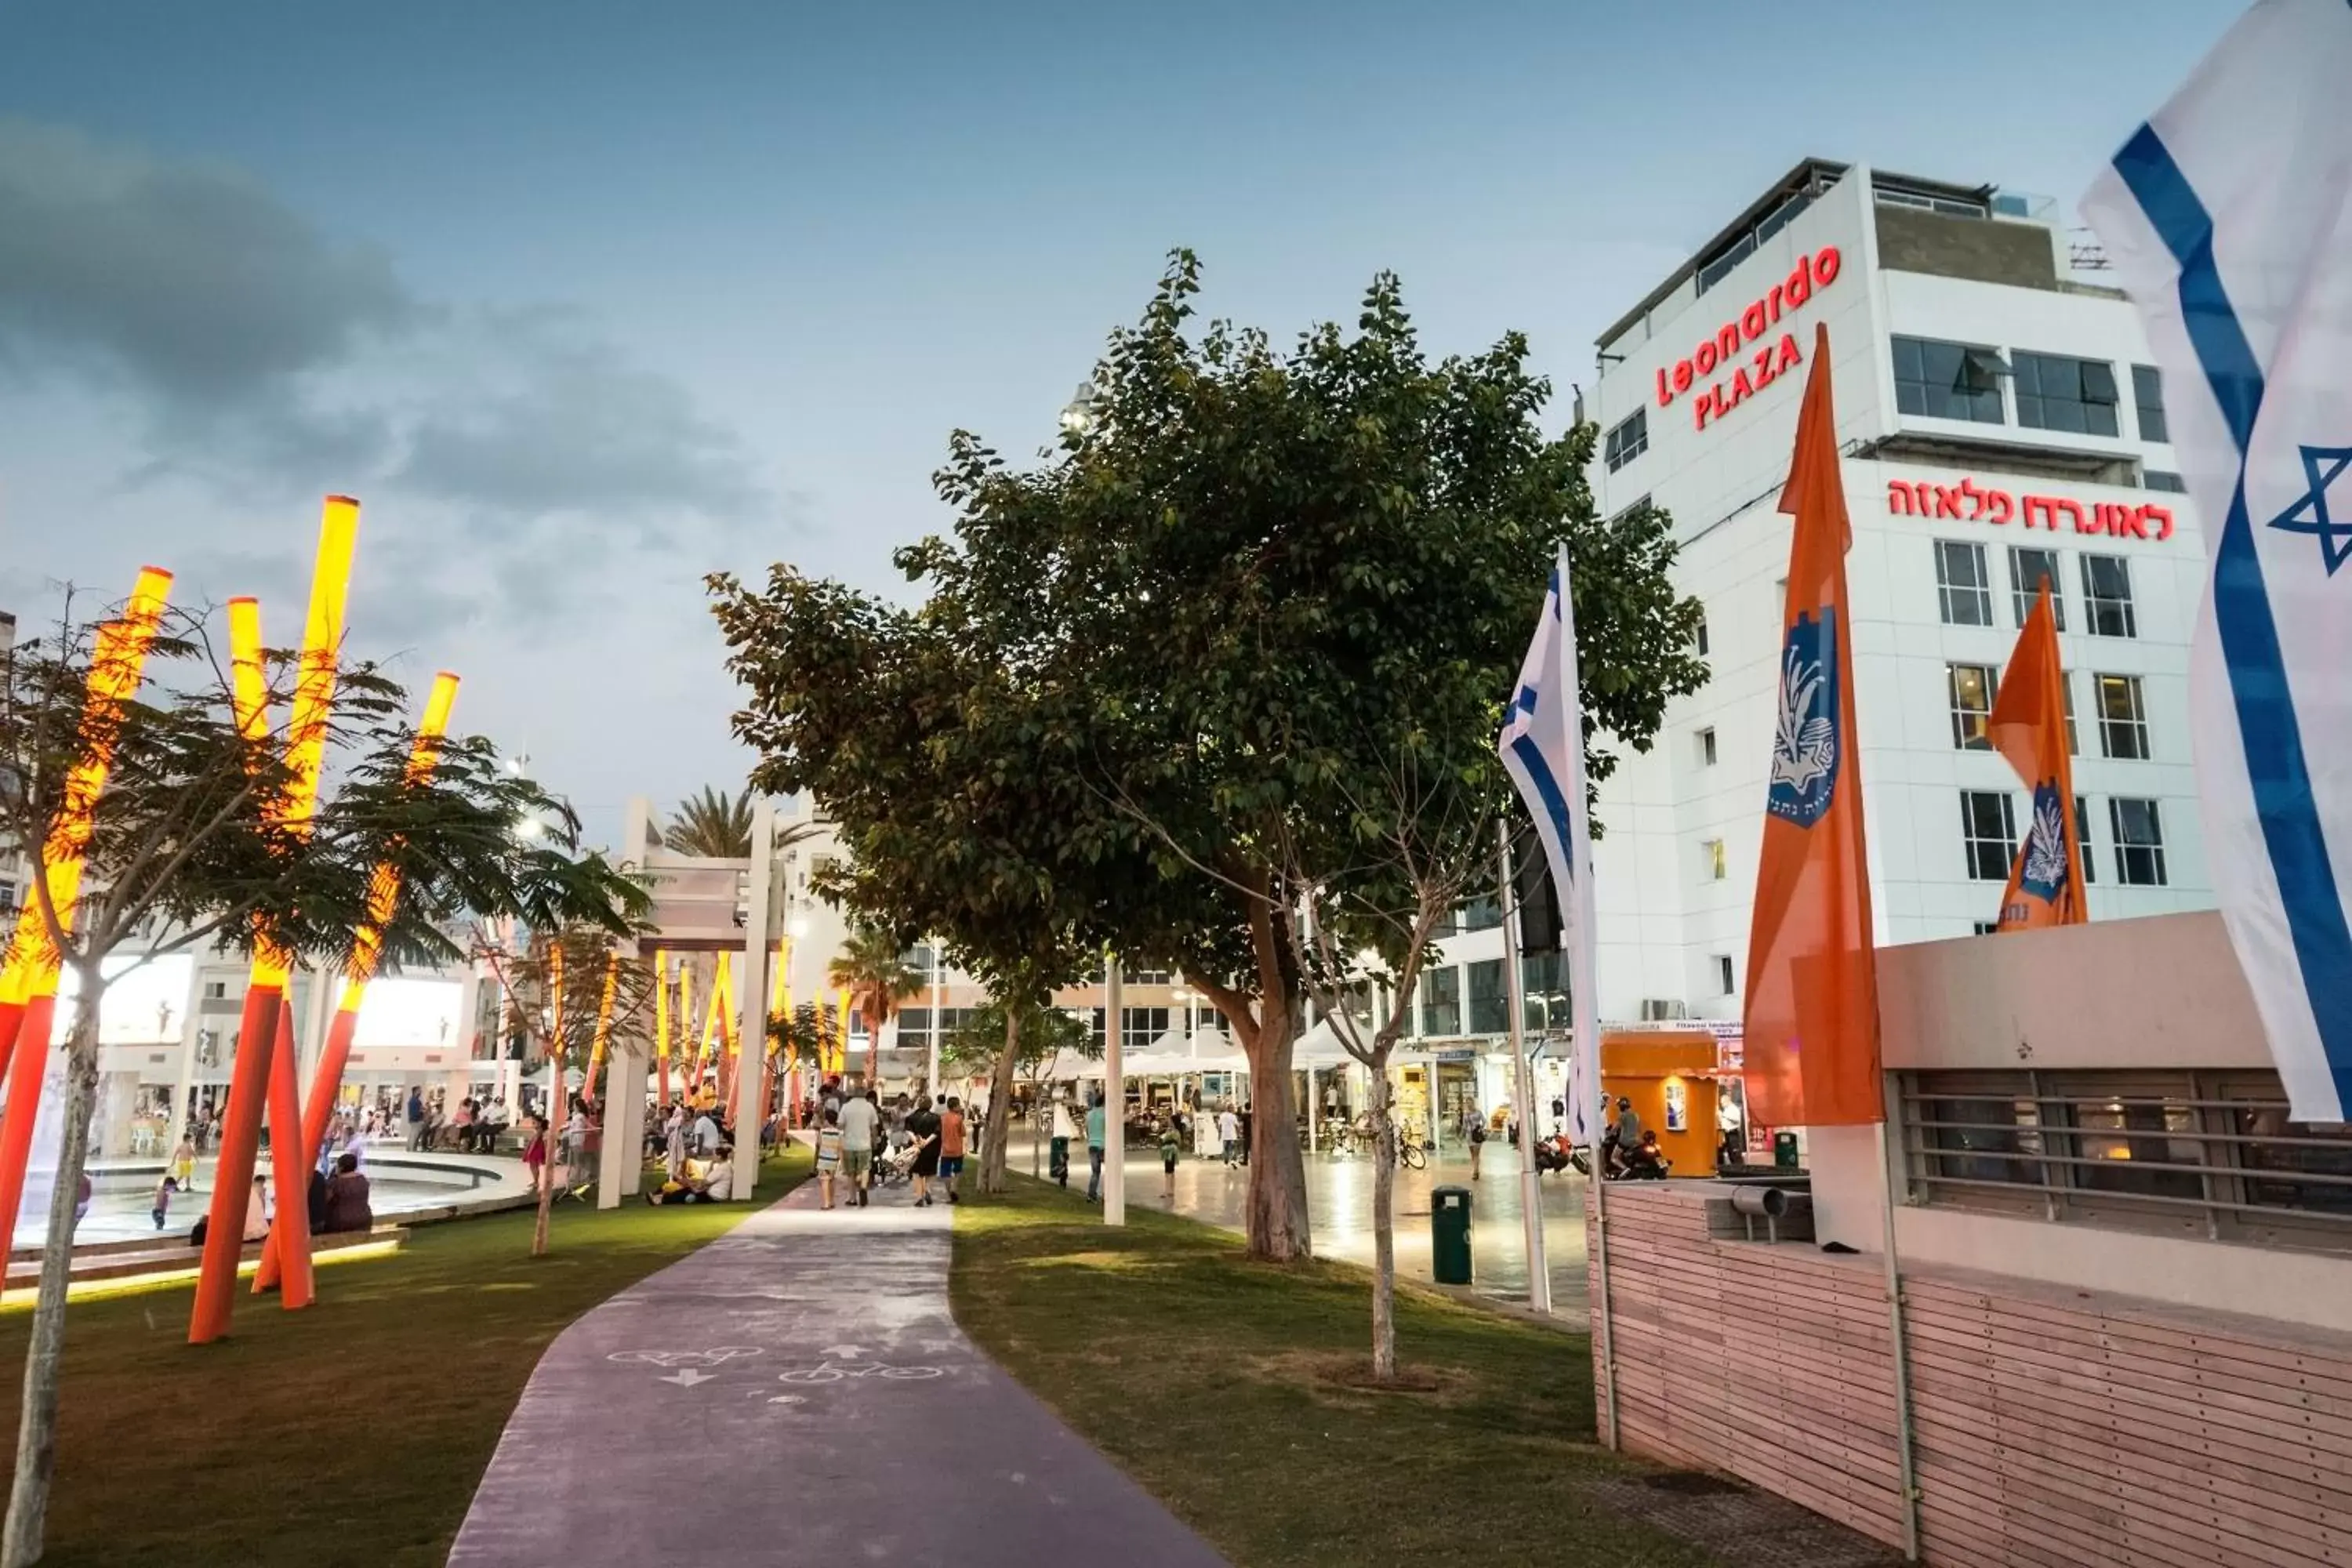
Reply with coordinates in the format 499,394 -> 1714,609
0,992 -> 106,1568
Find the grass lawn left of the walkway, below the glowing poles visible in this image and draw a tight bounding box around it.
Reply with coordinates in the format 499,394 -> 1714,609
0,1147 -> 809,1568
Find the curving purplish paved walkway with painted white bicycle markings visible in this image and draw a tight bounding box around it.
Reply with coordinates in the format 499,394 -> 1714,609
449,1180 -> 1223,1568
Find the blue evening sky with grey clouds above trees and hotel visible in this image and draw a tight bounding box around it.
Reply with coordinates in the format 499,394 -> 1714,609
0,0 -> 2241,841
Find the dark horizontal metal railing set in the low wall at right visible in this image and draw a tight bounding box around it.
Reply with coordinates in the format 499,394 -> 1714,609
1898,1072 -> 2352,1253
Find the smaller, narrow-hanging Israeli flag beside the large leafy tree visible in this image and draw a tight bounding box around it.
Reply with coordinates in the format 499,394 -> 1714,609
1496,546 -> 1604,1147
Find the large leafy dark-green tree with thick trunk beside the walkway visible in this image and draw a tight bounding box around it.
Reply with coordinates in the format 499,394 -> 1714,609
717,252 -> 1703,1258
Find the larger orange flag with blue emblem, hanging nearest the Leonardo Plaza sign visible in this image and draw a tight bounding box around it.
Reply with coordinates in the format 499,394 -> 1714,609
1743,327 -> 1886,1126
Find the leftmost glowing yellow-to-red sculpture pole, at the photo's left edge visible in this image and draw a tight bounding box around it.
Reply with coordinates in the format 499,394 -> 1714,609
0,567 -> 172,1239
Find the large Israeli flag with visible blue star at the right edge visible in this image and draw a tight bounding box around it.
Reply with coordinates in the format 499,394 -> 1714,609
2084,0 -> 2352,1121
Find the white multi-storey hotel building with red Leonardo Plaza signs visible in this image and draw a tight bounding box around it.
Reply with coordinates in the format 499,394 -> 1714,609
1425,160 -> 2211,1067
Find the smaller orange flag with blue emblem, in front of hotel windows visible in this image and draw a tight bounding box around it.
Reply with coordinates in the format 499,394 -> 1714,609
1987,579 -> 2091,931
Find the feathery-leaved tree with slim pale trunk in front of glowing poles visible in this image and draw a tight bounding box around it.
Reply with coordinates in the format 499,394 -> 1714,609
0,593 -> 644,1568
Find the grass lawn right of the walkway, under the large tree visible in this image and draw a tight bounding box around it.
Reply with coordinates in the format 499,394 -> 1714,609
953,1178 -> 1717,1568
